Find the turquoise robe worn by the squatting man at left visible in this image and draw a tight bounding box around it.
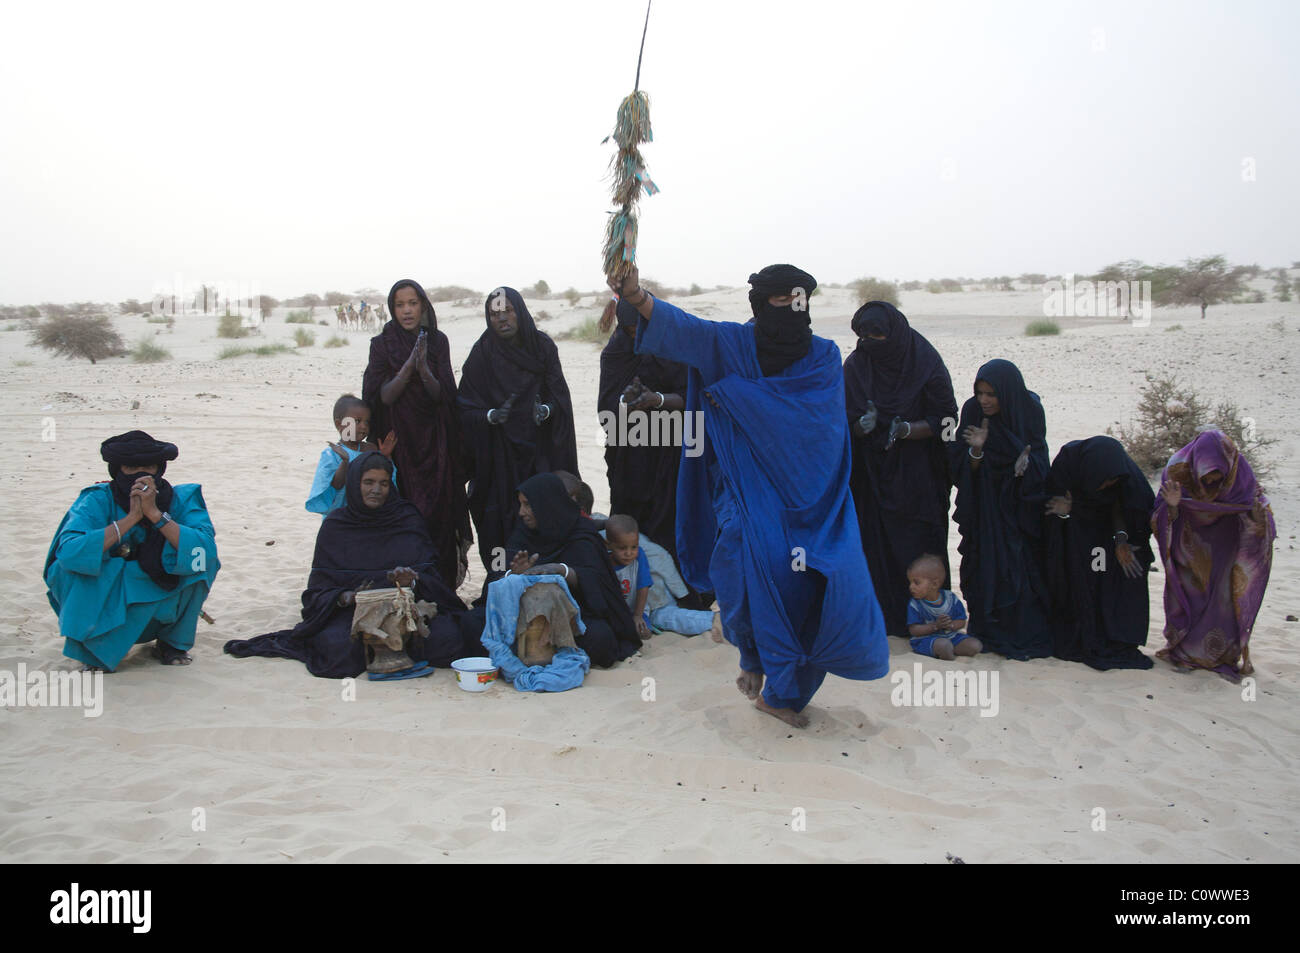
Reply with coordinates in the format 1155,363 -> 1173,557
46,484 -> 221,671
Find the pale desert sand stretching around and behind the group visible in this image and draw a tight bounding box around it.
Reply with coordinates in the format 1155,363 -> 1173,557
0,284 -> 1300,863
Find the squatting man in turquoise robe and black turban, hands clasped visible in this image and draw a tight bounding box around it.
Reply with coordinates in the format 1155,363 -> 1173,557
46,430 -> 220,672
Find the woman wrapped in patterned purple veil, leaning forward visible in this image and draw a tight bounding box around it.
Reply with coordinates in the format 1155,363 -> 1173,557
1151,430 -> 1278,681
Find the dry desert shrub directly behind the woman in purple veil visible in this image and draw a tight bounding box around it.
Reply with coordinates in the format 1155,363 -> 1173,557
1106,376 -> 1278,482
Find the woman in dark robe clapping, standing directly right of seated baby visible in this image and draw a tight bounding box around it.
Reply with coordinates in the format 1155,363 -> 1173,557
948,359 -> 1052,660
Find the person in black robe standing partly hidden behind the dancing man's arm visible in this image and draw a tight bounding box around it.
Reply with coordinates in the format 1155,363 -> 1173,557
597,300 -> 686,560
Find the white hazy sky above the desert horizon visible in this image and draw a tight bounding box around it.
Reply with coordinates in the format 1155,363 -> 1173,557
0,0 -> 1300,304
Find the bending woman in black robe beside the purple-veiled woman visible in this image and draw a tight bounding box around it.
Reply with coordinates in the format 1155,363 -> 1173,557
1045,437 -> 1156,671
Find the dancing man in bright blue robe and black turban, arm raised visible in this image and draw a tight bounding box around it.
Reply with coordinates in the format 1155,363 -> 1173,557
610,265 -> 889,728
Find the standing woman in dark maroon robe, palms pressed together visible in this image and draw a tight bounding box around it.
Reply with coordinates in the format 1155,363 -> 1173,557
361,278 -> 473,589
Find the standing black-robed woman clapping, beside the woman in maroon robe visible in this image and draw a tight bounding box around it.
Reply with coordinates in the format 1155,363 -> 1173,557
457,287 -> 579,571
